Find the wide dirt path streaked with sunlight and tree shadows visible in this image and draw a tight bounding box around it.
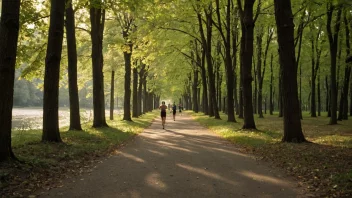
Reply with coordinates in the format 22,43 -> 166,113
43,115 -> 303,198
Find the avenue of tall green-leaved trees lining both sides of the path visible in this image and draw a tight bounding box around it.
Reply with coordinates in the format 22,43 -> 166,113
0,0 -> 352,161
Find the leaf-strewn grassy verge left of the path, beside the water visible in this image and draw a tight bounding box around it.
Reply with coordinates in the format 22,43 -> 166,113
0,112 -> 157,197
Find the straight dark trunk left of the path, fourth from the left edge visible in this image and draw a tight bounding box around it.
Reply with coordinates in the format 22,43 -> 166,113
89,0 -> 108,127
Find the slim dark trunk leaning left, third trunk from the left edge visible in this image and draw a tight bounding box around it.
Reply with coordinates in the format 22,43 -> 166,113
65,0 -> 82,130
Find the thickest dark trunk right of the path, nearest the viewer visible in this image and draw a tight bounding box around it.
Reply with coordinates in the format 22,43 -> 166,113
274,0 -> 306,143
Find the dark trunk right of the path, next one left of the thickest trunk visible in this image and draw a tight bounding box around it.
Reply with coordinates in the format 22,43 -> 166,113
237,0 -> 256,129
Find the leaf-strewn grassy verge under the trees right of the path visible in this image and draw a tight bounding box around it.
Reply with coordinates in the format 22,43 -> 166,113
191,110 -> 352,197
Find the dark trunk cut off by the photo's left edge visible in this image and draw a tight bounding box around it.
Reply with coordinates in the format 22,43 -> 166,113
0,0 -> 20,162
